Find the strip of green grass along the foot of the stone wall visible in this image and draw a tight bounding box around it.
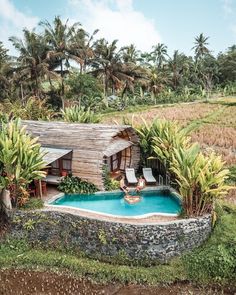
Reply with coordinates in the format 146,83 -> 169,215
0,240 -> 186,284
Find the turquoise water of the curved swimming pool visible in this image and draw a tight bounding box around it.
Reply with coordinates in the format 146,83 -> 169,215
51,191 -> 181,216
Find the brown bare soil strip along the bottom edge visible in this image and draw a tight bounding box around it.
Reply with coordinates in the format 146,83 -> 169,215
0,270 -> 236,295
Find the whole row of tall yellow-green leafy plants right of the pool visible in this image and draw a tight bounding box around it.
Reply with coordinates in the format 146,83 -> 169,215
137,120 -> 229,216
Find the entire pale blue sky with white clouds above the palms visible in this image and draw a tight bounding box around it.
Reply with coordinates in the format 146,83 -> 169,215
0,0 -> 236,56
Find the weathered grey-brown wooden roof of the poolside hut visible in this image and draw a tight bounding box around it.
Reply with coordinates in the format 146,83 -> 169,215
22,121 -> 138,156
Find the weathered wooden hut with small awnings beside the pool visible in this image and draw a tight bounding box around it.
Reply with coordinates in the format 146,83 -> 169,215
23,121 -> 140,190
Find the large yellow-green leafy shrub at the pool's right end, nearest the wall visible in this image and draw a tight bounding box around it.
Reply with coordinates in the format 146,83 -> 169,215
170,144 -> 229,216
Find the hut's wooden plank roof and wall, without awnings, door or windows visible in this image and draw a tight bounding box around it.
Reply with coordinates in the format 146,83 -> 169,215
23,121 -> 139,190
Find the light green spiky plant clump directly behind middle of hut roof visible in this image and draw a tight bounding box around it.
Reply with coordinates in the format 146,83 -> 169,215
61,106 -> 101,123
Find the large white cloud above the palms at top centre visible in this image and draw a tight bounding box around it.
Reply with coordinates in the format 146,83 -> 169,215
68,0 -> 161,51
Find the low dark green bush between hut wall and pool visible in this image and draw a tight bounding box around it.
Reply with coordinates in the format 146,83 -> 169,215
58,176 -> 98,194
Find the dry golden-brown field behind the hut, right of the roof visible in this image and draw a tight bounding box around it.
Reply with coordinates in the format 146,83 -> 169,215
103,98 -> 236,166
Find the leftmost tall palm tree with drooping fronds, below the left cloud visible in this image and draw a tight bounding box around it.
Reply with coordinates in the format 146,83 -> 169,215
9,29 -> 51,98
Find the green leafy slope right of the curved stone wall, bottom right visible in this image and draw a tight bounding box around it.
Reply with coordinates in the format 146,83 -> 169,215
183,204 -> 236,283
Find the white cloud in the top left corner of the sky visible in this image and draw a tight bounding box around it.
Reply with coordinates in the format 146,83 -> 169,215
0,0 -> 39,54
